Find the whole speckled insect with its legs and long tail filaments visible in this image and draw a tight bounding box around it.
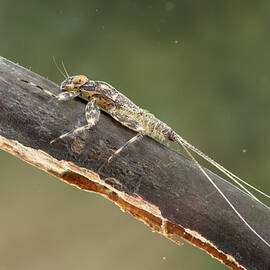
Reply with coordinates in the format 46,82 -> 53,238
18,75 -> 270,247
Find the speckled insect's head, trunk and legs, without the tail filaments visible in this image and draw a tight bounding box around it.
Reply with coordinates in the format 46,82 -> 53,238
45,75 -> 180,157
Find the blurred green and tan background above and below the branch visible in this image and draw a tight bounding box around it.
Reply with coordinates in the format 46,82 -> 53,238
0,0 -> 270,270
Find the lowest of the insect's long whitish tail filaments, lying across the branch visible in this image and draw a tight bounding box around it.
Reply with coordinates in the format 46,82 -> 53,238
175,135 -> 270,247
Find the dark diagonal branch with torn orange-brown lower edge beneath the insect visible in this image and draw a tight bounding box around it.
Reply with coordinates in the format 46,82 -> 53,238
0,58 -> 270,269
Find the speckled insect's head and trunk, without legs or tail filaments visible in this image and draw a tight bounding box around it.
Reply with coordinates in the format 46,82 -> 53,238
61,75 -> 174,140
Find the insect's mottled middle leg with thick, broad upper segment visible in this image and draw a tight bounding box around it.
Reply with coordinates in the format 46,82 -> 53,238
50,99 -> 100,144
